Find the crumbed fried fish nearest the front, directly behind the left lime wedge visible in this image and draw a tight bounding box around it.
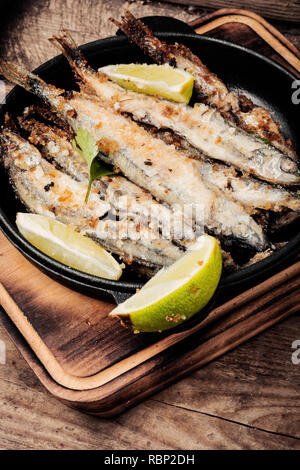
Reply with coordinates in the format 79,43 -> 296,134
0,129 -> 188,268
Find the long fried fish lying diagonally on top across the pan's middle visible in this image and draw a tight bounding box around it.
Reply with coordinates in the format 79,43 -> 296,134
0,61 -> 268,251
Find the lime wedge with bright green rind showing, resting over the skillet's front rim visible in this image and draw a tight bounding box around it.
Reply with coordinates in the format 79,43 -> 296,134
110,235 -> 222,332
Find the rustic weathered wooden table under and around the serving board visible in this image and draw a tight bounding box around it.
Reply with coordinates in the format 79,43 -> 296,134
0,0 -> 300,449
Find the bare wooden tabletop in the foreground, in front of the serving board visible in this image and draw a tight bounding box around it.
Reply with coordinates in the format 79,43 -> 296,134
0,306 -> 300,449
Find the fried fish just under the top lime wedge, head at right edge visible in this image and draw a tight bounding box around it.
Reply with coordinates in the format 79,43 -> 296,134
48,33 -> 300,186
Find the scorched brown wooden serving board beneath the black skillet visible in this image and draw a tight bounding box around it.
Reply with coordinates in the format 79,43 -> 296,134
0,11 -> 300,416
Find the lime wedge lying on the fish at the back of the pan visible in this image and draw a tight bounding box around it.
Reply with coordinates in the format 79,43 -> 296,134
99,64 -> 194,103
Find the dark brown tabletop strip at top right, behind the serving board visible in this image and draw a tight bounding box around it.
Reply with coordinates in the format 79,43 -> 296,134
165,0 -> 300,23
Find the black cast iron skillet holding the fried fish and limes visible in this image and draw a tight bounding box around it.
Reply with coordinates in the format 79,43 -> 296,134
0,17 -> 300,320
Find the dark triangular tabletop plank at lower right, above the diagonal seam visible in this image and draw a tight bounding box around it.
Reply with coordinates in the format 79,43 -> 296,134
155,313 -> 300,438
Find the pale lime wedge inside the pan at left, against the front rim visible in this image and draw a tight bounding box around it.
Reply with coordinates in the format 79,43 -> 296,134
16,212 -> 122,279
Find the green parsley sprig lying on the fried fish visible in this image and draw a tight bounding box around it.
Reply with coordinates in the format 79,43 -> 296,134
72,129 -> 114,203
